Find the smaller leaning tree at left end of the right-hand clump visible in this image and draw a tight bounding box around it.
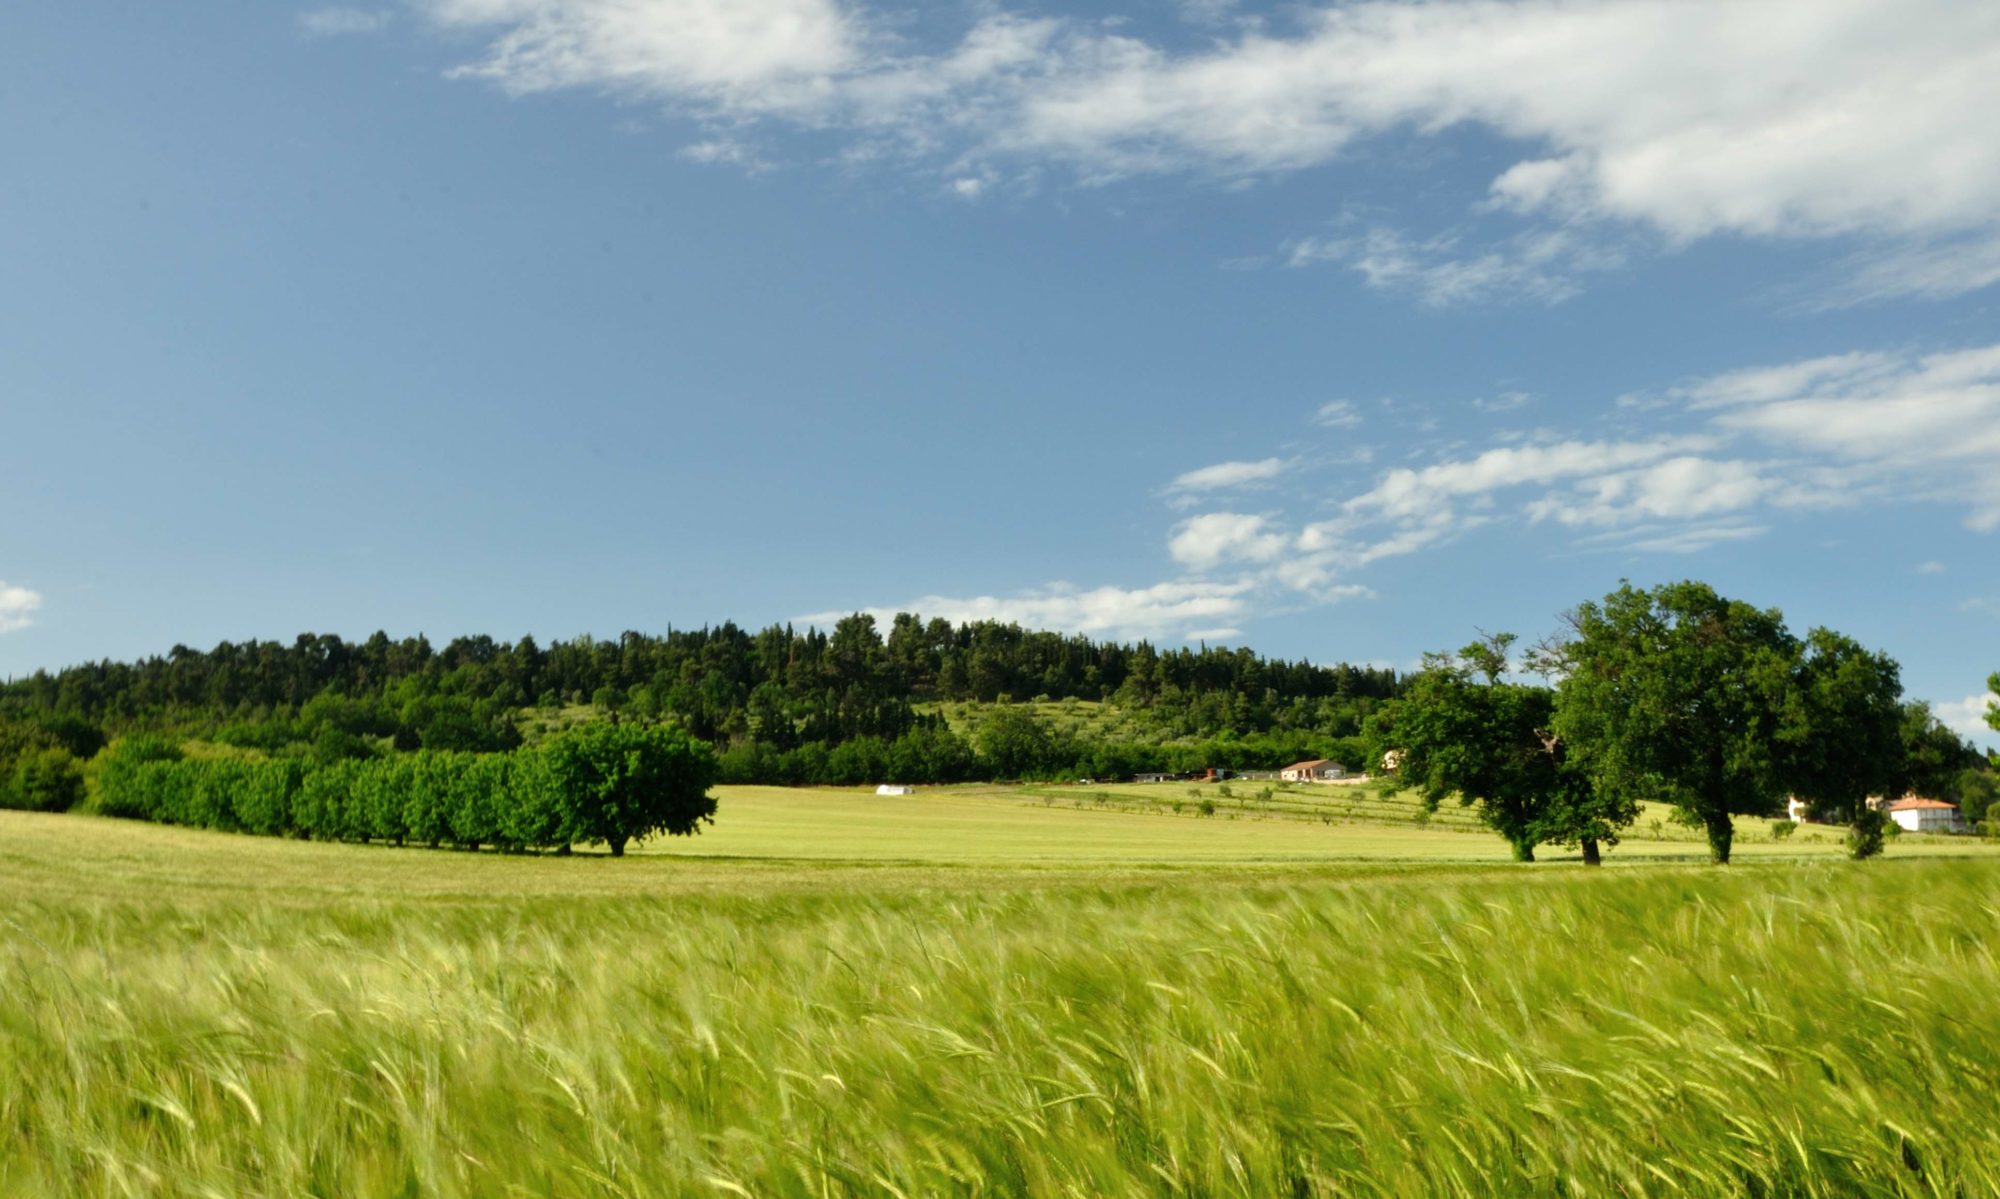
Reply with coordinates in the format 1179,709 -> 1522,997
1372,633 -> 1638,865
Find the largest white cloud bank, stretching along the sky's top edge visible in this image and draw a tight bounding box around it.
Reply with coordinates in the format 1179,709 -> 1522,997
416,0 -> 2000,302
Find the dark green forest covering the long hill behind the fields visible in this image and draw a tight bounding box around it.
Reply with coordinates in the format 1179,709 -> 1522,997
0,613 -> 1400,809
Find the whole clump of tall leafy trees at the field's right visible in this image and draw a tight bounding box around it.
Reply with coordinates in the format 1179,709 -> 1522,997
1370,582 -> 2000,863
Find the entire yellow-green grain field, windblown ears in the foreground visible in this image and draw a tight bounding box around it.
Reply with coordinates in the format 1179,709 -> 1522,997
0,789 -> 2000,1197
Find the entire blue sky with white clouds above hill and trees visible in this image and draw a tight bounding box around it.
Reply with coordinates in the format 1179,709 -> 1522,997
0,0 -> 2000,743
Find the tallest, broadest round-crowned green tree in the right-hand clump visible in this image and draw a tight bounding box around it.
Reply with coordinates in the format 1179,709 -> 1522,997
1548,582 -> 1902,863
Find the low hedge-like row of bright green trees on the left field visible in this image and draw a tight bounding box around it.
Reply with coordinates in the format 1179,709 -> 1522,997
98,721 -> 716,855
